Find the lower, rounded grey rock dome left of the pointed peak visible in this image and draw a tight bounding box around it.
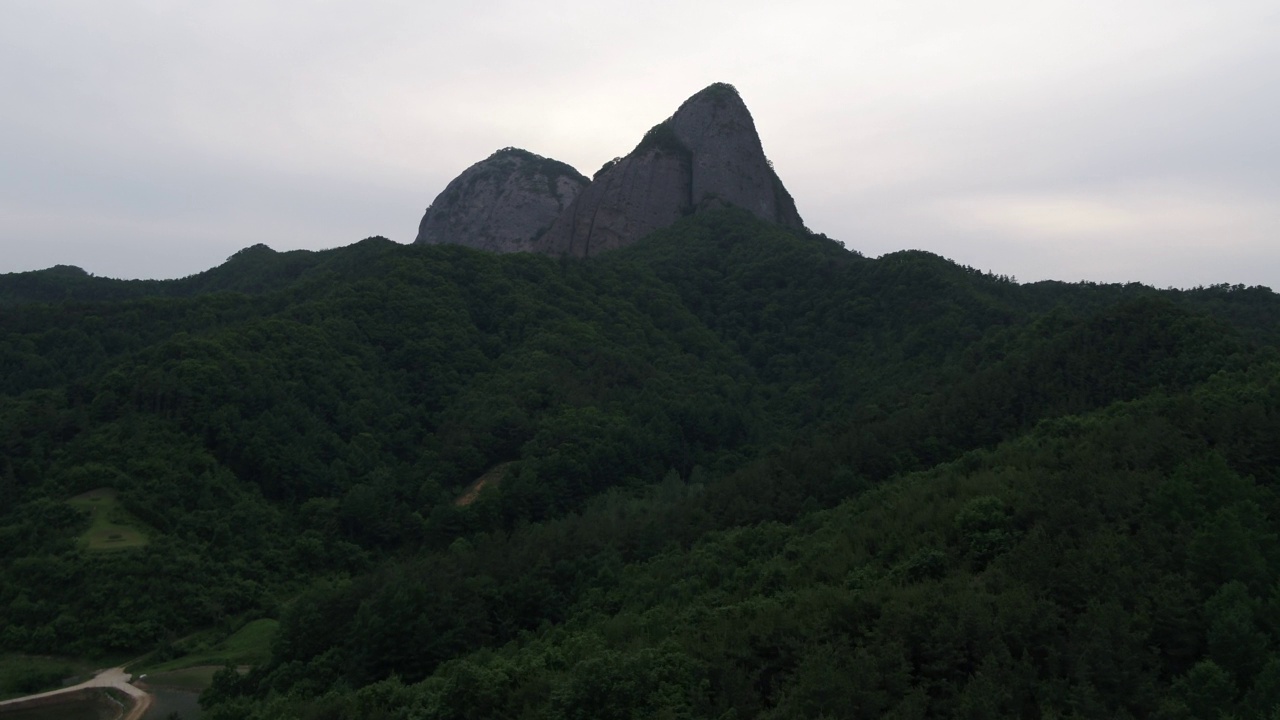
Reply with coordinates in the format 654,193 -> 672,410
413,147 -> 589,252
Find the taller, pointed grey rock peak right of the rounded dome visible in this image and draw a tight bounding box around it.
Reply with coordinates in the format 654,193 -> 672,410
534,83 -> 804,258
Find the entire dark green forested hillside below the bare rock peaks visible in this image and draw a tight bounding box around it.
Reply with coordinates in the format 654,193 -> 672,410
0,210 -> 1280,717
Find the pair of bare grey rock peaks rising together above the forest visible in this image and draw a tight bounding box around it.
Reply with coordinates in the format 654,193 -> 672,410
415,82 -> 804,258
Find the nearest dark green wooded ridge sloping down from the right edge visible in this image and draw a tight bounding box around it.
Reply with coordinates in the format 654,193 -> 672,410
206,364 -> 1280,719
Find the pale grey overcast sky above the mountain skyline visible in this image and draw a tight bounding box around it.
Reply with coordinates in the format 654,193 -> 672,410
0,0 -> 1280,290
